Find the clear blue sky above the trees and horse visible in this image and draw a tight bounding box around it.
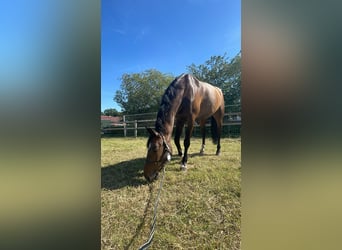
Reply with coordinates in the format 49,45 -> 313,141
101,0 -> 241,111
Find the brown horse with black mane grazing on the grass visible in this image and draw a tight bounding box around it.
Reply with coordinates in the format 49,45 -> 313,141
144,74 -> 224,181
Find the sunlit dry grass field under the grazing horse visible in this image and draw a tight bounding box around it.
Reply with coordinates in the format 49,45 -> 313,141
101,138 -> 241,249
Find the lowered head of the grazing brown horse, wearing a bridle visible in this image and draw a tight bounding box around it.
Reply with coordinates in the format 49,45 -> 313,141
144,128 -> 172,182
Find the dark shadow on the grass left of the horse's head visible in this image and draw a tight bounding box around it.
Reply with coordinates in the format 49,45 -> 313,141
101,158 -> 147,190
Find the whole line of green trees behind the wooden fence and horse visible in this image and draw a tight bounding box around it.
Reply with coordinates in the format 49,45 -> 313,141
102,52 -> 241,116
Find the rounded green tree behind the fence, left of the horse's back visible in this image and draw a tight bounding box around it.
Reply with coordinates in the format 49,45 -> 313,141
114,69 -> 174,114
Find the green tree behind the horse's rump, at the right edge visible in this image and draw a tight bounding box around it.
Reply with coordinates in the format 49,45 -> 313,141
187,52 -> 241,105
